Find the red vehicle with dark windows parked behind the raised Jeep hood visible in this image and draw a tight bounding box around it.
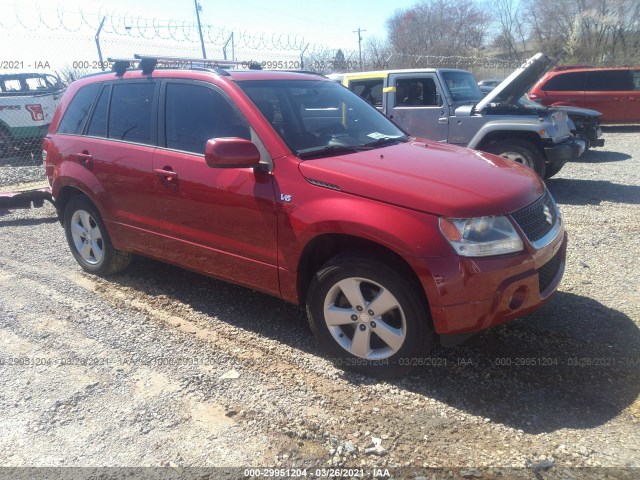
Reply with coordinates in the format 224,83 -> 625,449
529,65 -> 640,124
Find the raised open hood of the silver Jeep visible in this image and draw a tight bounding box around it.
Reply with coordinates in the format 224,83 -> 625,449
476,53 -> 555,111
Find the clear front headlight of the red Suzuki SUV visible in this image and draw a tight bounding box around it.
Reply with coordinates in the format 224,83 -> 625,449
440,215 -> 523,257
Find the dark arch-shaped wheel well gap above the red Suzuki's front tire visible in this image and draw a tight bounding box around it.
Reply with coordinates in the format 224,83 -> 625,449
298,234 -> 428,310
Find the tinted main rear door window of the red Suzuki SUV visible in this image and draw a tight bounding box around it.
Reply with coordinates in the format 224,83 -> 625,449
109,82 -> 156,145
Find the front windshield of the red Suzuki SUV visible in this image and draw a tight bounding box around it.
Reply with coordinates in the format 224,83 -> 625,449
238,80 -> 408,158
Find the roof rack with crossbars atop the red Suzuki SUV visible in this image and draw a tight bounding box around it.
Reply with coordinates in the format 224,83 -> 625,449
107,53 -> 262,76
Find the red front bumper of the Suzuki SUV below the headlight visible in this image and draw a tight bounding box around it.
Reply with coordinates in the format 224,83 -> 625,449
421,230 -> 567,334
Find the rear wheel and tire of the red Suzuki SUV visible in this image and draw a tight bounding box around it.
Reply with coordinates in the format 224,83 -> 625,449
64,195 -> 132,276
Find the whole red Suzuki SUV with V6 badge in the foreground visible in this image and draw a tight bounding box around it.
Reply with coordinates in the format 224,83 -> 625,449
44,59 -> 567,373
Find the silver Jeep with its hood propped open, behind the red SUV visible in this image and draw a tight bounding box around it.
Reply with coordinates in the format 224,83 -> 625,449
335,53 -> 586,178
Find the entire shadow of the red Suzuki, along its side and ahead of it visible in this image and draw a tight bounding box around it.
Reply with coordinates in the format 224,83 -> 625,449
111,258 -> 640,433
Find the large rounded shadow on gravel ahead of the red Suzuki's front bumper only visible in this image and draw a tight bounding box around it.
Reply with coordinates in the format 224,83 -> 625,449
358,292 -> 640,434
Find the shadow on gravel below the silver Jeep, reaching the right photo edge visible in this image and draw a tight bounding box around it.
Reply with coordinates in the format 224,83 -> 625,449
545,178 -> 640,205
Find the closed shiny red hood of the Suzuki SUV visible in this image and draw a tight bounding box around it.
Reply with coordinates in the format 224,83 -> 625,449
299,139 -> 544,218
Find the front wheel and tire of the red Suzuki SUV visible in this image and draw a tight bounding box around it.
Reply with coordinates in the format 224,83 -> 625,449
307,255 -> 436,377
